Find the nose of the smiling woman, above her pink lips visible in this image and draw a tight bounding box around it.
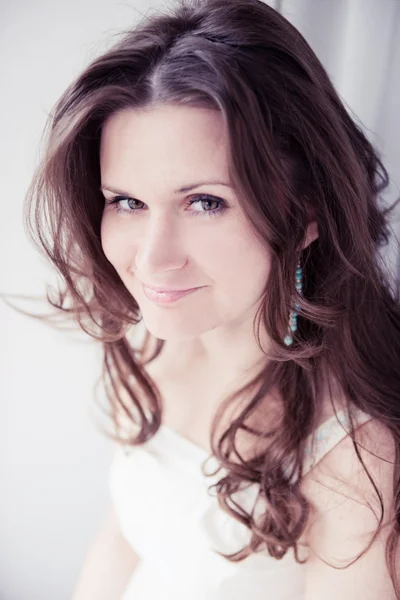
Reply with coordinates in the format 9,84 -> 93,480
135,217 -> 187,274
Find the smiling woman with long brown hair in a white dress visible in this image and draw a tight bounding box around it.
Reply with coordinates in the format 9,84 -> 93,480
28,0 -> 400,600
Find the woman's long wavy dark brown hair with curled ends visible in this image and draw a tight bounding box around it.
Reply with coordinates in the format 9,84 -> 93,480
21,0 -> 400,598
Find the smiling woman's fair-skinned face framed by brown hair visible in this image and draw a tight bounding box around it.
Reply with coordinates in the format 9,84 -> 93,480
100,105 -> 270,341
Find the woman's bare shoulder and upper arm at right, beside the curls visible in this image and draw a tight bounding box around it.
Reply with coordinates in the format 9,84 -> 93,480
301,418 -> 400,600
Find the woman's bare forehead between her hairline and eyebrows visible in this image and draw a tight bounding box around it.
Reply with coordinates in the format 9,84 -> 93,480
100,105 -> 229,185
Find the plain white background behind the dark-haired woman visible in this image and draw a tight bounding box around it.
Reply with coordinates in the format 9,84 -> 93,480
0,0 -> 400,600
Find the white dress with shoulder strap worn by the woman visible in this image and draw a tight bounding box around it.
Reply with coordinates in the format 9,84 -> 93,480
109,411 -> 371,600
